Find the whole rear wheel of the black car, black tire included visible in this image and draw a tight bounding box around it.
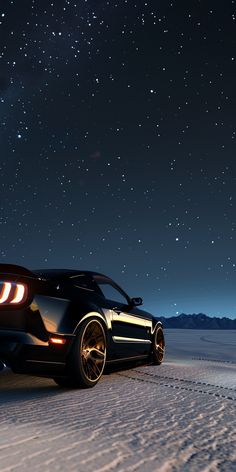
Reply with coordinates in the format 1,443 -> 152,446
54,318 -> 106,388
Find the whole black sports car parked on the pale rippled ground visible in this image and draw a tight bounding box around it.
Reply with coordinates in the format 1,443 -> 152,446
0,264 -> 165,387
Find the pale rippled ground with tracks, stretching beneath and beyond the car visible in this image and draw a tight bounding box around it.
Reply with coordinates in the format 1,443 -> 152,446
0,330 -> 236,472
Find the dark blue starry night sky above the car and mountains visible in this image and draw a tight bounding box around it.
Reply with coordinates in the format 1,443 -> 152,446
0,0 -> 236,318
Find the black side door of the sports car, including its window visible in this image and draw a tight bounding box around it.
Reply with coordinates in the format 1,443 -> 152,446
95,276 -> 152,358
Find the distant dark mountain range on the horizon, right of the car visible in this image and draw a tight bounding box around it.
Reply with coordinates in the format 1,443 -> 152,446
158,313 -> 236,329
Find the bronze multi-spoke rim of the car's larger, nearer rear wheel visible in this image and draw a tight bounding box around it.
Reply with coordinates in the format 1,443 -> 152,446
80,319 -> 106,383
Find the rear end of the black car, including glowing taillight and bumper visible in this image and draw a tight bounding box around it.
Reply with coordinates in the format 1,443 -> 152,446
0,264 -> 70,376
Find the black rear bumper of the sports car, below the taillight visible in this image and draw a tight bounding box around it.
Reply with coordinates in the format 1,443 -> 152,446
0,330 -> 73,377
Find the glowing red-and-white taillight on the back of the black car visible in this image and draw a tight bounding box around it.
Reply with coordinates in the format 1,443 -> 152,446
0,280 -> 28,305
